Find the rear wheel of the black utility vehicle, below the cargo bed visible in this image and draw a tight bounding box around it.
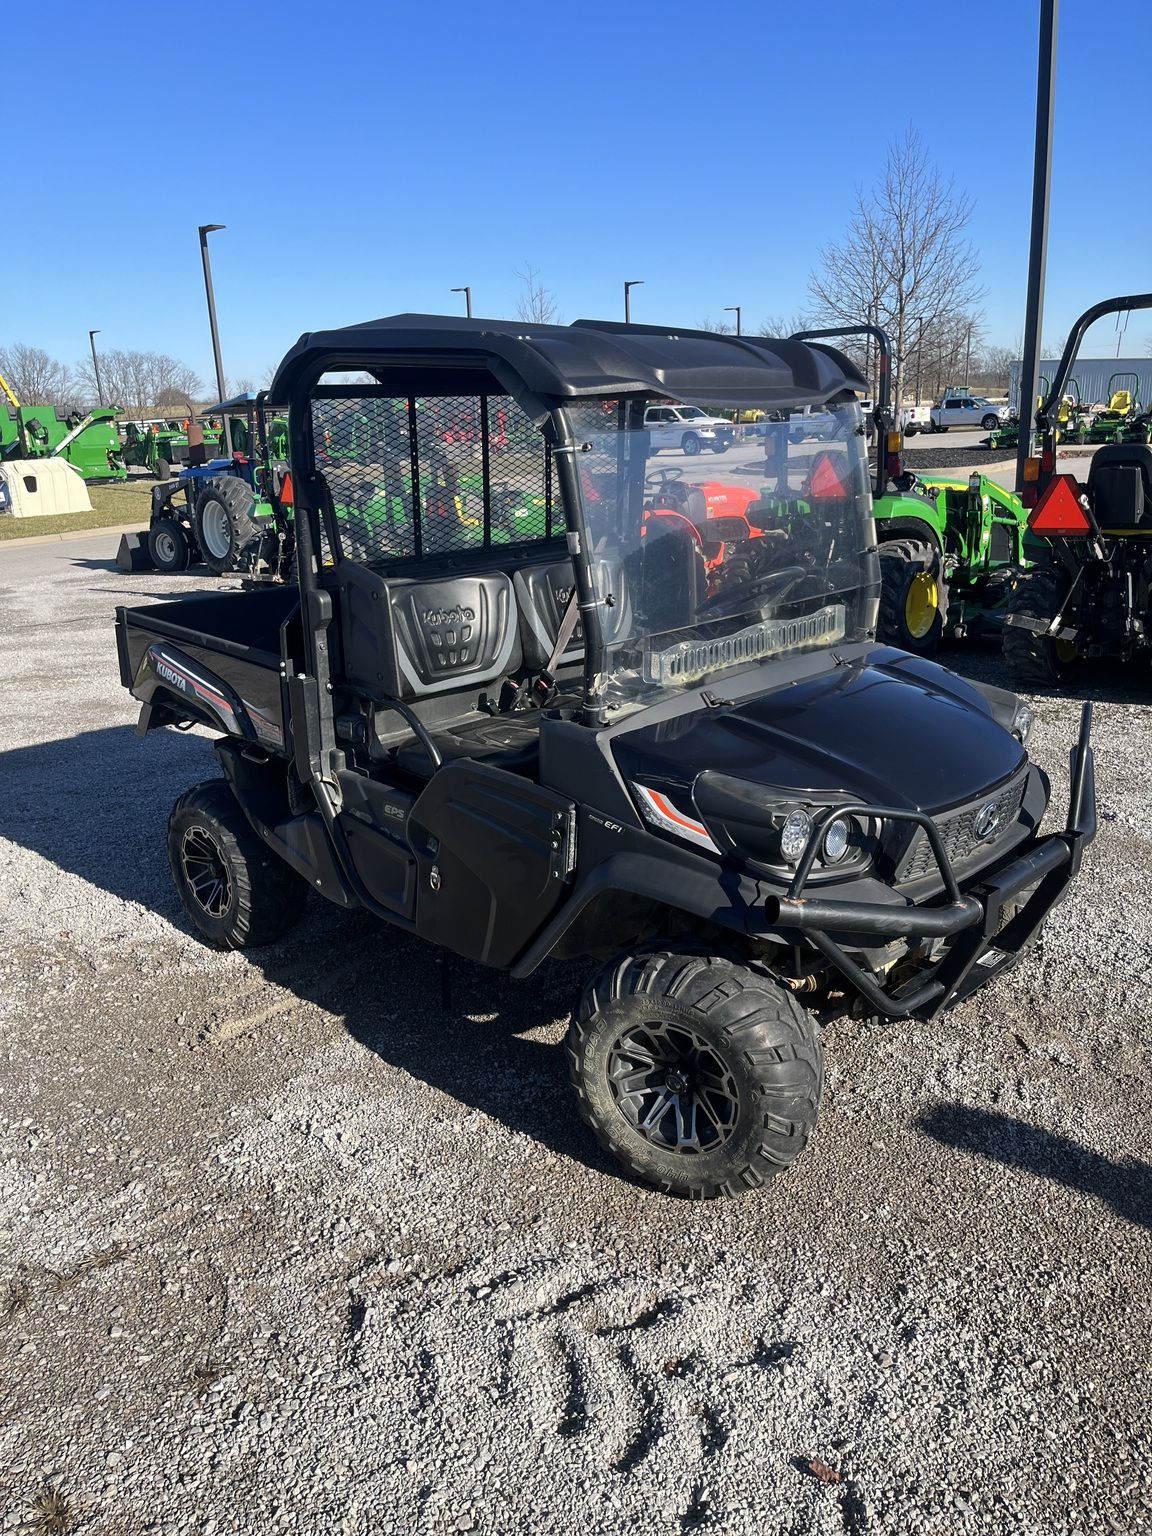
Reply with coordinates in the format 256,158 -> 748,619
167,779 -> 307,949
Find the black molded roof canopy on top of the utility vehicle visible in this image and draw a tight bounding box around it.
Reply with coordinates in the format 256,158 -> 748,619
269,315 -> 868,409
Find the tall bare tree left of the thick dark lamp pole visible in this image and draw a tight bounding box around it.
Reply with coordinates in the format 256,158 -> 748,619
809,129 -> 982,402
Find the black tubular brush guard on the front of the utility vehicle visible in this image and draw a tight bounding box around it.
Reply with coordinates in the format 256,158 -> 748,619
765,703 -> 1097,1020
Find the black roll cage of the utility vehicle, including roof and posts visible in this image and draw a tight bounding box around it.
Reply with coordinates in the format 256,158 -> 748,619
269,315 -> 866,731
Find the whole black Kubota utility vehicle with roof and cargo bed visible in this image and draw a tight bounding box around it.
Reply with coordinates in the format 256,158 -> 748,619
118,315 -> 1095,1195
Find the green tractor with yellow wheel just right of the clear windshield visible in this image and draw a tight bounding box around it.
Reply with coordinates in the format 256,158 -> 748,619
793,326 -> 1031,656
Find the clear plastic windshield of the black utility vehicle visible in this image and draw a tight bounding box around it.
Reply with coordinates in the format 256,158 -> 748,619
568,401 -> 879,711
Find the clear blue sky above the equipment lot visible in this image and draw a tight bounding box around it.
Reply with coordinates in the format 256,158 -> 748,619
9,0 -> 1152,381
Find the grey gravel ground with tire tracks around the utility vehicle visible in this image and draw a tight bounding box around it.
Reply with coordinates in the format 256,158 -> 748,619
0,541 -> 1152,1536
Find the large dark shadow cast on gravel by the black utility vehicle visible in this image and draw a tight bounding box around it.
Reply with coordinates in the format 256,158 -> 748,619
0,712 -> 621,1178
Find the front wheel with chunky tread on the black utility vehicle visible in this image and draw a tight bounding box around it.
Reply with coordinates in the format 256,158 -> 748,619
567,951 -> 823,1200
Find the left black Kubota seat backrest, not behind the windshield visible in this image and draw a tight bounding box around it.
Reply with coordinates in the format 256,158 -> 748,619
341,562 -> 521,699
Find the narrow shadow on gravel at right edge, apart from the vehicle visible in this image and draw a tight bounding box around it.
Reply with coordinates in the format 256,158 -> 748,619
920,1104 -> 1152,1230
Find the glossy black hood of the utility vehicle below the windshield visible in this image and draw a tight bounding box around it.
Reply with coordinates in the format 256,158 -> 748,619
613,647 -> 1025,813
